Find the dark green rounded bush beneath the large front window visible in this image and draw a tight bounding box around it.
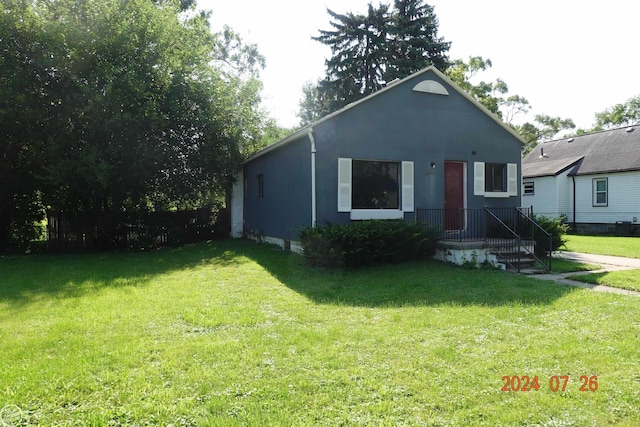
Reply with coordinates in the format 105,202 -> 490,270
299,220 -> 437,268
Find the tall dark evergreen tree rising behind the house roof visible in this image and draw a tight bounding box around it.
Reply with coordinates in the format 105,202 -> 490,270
299,0 -> 450,124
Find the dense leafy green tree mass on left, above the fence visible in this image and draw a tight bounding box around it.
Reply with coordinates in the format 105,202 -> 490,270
0,0 -> 271,250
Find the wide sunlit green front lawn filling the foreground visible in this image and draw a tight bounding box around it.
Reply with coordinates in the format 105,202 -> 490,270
0,241 -> 640,426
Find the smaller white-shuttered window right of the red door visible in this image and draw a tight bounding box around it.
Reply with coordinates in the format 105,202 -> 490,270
473,162 -> 518,198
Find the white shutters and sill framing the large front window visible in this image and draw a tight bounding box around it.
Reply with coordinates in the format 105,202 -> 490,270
337,157 -> 415,220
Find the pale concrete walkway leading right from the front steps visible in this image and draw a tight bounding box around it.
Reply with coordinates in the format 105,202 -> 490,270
529,251 -> 640,297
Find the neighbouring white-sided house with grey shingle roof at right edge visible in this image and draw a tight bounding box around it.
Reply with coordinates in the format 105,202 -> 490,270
522,126 -> 640,234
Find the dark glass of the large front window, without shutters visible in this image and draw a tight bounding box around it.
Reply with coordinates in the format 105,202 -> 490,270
351,160 -> 400,209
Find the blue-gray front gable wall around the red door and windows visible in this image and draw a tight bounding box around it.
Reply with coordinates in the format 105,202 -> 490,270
314,71 -> 521,224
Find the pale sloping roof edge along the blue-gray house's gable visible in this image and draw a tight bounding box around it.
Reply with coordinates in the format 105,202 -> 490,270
245,65 -> 526,163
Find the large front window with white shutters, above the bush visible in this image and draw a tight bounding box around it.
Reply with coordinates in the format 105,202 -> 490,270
338,158 -> 414,220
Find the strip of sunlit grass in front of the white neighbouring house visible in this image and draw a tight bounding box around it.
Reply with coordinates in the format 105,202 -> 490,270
565,234 -> 640,258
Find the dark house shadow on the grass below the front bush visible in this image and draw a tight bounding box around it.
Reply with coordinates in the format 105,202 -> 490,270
238,241 -> 577,307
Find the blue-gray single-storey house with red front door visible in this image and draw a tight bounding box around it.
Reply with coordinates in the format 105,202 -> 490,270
231,67 -> 523,250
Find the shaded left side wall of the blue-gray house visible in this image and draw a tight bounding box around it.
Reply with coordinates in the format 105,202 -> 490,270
244,136 -> 311,239
